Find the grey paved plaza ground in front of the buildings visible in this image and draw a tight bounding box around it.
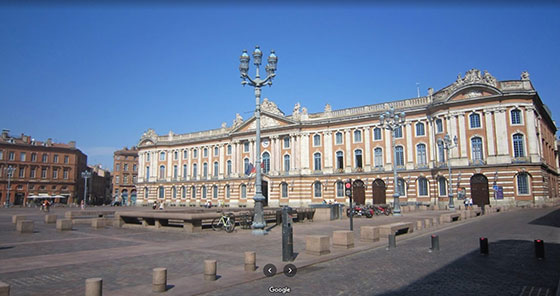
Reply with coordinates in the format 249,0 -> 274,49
0,207 -> 560,295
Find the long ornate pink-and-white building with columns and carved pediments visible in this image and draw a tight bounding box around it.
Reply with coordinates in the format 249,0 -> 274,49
137,69 -> 559,206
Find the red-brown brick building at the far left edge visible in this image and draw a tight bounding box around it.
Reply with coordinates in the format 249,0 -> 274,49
0,130 -> 87,205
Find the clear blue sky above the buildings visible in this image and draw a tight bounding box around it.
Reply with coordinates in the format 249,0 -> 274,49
0,2 -> 560,168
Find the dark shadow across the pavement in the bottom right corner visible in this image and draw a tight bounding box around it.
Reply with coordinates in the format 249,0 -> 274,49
376,240 -> 560,296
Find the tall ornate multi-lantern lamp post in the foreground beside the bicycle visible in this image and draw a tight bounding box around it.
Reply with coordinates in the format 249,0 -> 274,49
239,45 -> 278,235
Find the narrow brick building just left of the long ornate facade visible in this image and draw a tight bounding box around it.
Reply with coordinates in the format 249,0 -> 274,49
113,147 -> 138,205
